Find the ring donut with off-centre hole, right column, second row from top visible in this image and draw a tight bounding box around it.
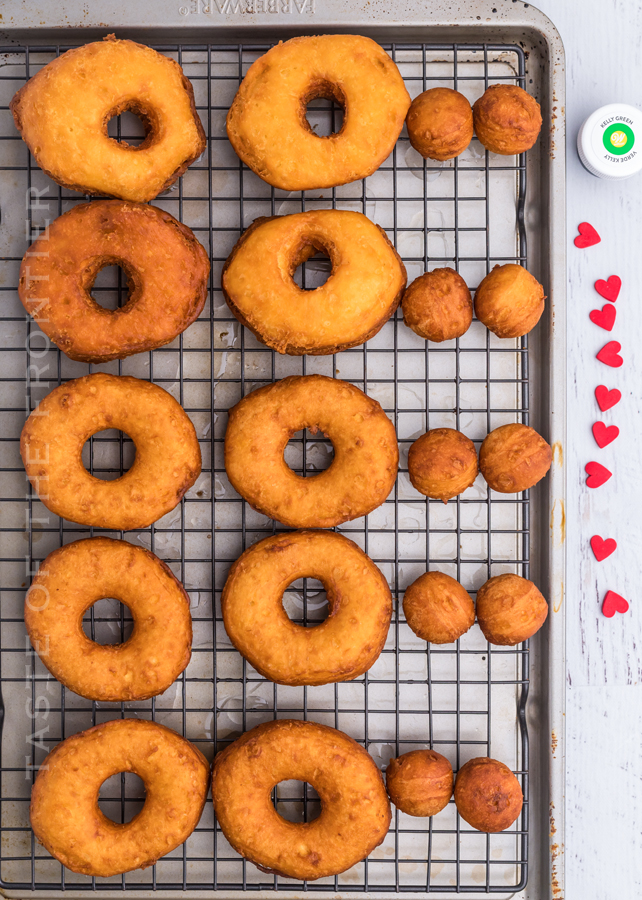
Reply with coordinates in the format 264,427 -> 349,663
222,209 -> 406,356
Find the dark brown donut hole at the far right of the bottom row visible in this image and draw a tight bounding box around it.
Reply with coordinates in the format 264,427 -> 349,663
455,756 -> 524,834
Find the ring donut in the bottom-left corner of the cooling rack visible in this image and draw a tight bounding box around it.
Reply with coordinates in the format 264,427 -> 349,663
30,719 -> 210,878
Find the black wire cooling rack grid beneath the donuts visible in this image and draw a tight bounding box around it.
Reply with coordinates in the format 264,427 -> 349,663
0,44 -> 529,894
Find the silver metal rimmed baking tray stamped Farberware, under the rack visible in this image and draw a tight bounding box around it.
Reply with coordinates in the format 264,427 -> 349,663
0,0 -> 565,900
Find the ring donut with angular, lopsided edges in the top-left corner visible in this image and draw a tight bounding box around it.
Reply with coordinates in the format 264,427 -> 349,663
10,34 -> 205,203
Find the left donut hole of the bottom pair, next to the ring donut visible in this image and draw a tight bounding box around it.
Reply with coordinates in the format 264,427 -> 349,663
386,750 -> 455,816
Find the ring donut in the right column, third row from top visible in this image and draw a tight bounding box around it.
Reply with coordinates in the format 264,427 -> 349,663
225,375 -> 399,528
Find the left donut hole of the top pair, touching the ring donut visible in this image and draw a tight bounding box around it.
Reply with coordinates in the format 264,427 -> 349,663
406,88 -> 473,160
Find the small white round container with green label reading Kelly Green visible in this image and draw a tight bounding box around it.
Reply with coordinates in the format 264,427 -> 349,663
577,103 -> 642,178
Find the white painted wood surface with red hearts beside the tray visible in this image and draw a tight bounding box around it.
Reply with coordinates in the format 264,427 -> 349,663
536,0 -> 642,900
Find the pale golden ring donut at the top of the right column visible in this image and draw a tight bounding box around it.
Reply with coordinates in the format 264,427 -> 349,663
227,34 -> 410,191
